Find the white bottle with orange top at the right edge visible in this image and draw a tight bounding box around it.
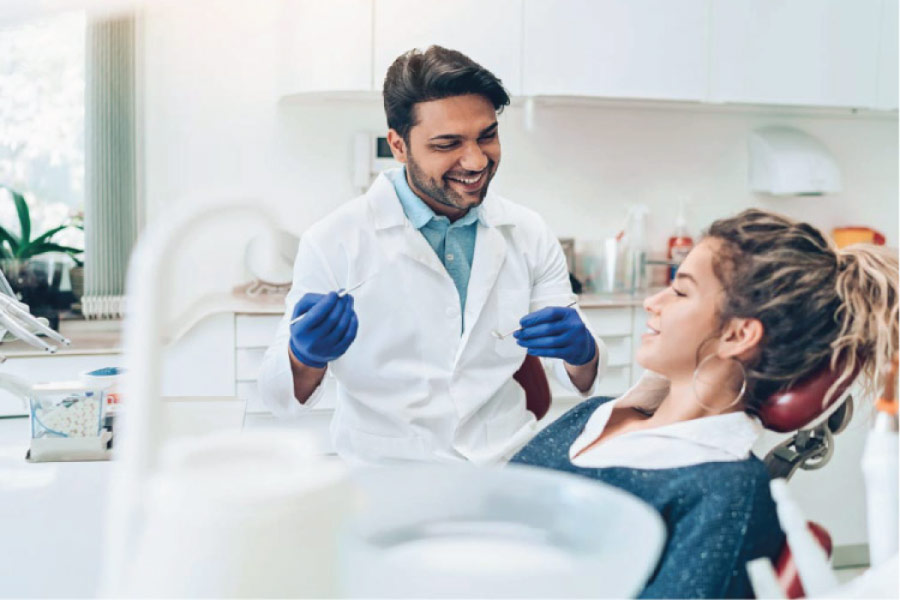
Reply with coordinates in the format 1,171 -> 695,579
861,357 -> 898,567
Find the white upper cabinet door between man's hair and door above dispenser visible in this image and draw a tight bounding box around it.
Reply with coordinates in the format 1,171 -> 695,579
522,0 -> 708,100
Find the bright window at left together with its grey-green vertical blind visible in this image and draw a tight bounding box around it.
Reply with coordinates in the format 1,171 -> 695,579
0,12 -> 140,318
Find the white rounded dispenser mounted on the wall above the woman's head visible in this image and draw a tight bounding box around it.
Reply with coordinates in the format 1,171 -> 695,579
748,127 -> 841,196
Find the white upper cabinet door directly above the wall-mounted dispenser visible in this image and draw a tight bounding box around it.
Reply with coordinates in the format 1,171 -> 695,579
710,0 -> 884,107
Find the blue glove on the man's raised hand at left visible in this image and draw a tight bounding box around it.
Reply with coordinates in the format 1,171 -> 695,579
290,292 -> 359,369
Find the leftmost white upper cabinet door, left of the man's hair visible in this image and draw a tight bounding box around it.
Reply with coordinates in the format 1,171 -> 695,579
279,0 -> 373,96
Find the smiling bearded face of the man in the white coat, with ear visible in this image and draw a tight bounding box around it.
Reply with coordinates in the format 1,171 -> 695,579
388,94 -> 500,220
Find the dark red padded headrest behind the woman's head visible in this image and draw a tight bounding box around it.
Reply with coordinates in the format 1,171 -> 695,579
759,365 -> 859,433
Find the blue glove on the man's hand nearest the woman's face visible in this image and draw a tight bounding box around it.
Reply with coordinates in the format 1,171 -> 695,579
513,306 -> 597,366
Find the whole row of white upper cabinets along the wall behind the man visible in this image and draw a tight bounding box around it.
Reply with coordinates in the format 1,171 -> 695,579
280,0 -> 898,110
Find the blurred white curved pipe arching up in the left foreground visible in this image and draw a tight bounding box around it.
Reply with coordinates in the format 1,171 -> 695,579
101,202 -> 277,597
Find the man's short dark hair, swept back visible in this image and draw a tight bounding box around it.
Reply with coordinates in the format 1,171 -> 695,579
383,46 -> 509,142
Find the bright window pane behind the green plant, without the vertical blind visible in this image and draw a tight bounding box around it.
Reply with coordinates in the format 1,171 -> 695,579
0,12 -> 86,248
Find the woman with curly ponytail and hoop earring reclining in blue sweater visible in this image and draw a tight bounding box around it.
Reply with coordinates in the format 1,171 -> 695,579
512,210 -> 898,598
